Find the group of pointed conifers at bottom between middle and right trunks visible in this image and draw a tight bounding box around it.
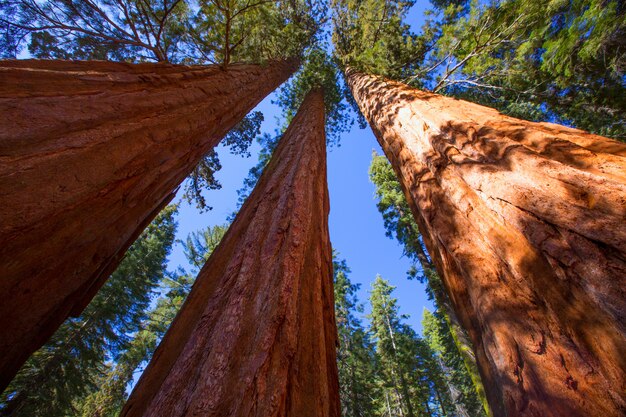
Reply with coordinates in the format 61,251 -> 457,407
334,258 -> 485,417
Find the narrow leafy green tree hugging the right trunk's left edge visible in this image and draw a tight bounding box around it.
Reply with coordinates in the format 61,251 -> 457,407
369,152 -> 490,414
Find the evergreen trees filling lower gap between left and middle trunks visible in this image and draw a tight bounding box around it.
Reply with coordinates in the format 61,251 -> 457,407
0,211 -> 227,417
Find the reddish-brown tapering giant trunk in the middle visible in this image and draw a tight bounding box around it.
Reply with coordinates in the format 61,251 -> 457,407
121,91 -> 339,417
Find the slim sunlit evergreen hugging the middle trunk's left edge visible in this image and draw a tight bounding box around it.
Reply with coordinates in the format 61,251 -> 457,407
76,226 -> 227,417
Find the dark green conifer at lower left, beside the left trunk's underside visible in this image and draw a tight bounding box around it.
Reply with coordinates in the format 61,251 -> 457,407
0,206 -> 176,417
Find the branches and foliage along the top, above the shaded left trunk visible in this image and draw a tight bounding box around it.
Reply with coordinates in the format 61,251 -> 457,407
0,0 -> 323,63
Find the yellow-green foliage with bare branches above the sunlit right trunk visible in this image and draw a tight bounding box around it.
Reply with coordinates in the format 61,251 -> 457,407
419,0 -> 626,140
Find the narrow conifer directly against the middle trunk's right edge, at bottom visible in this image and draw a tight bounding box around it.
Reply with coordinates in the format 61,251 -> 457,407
333,253 -> 381,417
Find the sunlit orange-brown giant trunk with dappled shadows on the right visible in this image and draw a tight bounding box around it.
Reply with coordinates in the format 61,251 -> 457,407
347,70 -> 626,417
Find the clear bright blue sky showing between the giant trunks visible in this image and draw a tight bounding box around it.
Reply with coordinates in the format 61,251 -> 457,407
168,0 -> 433,333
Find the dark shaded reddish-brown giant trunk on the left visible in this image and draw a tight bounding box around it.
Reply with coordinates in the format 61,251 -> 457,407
0,60 -> 296,388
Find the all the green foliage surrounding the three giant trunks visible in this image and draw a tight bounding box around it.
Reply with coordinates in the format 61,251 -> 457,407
0,0 -> 626,417
